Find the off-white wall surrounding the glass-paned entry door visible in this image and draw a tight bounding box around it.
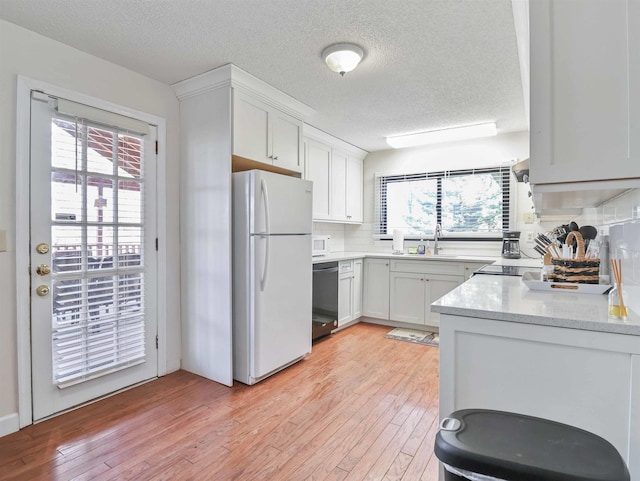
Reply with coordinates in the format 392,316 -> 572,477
0,20 -> 180,435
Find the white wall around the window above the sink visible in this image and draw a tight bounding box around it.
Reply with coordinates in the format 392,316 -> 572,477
344,132 -> 544,257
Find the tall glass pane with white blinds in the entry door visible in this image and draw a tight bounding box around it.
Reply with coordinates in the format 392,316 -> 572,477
51,109 -> 145,388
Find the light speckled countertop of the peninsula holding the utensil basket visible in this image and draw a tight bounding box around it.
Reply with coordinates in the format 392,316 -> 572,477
431,275 -> 640,336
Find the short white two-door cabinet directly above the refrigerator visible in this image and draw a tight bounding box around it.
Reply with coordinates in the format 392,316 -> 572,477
233,90 -> 303,173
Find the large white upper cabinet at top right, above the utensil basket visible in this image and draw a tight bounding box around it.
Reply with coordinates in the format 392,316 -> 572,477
529,0 -> 640,184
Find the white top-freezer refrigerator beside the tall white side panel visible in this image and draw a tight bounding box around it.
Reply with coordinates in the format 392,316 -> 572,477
233,170 -> 313,384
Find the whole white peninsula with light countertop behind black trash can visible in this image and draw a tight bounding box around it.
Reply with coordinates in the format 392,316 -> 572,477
431,276 -> 640,479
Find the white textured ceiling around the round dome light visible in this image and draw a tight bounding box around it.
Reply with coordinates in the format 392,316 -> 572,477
0,0 -> 527,151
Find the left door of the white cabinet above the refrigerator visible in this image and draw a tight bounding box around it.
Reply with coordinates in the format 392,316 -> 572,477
233,91 -> 272,164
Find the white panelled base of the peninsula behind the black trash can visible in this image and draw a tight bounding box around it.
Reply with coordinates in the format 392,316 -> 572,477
439,314 -> 640,479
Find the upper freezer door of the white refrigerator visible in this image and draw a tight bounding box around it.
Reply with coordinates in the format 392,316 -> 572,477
250,170 -> 313,234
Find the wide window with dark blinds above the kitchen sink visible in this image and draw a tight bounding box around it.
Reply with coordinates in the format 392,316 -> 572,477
375,167 -> 510,239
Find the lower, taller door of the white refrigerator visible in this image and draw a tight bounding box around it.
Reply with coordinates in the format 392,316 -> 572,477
250,235 -> 312,378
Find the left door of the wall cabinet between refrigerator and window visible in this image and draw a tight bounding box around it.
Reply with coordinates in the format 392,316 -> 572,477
306,139 -> 331,220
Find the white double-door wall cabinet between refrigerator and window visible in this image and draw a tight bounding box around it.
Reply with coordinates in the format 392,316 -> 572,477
304,125 -> 366,224
